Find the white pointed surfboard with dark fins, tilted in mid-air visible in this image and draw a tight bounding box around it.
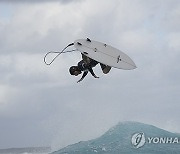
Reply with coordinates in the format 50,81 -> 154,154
74,38 -> 136,70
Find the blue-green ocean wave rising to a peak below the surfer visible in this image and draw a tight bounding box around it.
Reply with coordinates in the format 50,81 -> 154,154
52,122 -> 180,154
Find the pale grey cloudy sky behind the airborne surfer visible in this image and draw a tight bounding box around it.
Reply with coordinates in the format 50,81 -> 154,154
0,0 -> 180,150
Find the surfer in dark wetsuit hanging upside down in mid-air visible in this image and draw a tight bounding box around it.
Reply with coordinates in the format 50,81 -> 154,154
69,54 -> 111,83
